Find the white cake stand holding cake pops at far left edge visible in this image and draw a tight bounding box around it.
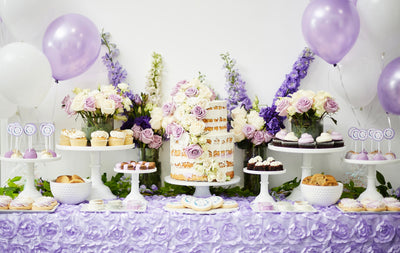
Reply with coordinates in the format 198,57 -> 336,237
0,155 -> 61,199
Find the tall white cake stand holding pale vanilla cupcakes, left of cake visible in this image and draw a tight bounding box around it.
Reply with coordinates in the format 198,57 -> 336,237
56,144 -> 135,200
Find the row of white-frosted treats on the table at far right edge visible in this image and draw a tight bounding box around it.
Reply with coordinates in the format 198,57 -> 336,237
337,197 -> 400,212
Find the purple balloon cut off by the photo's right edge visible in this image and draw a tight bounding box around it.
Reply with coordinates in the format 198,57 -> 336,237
378,57 -> 400,115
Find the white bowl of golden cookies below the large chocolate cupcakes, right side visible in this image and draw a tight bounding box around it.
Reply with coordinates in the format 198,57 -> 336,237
301,174 -> 343,206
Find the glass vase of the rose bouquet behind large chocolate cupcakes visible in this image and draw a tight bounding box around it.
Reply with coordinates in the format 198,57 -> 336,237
291,118 -> 324,139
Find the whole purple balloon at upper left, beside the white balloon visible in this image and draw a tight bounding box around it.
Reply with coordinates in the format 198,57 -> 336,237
43,14 -> 101,80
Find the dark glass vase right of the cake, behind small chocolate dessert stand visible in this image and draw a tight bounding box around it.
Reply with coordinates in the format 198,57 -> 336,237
243,145 -> 267,195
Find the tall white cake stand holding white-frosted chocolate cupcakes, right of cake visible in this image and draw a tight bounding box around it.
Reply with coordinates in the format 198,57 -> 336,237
268,144 -> 346,201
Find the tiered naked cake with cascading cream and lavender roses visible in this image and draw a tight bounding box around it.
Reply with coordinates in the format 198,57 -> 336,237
164,79 -> 234,182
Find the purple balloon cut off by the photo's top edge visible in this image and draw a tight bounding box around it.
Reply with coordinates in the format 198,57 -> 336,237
302,0 -> 360,64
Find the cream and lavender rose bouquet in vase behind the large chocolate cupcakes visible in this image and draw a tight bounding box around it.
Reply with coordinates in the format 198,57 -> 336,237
275,90 -> 339,138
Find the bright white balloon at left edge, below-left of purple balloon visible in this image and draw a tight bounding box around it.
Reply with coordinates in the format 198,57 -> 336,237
0,42 -> 53,107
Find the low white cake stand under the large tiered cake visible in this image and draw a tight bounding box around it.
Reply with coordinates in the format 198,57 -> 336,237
164,176 -> 240,198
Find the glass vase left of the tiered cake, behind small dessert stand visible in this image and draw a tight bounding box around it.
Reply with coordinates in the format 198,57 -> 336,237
139,148 -> 161,190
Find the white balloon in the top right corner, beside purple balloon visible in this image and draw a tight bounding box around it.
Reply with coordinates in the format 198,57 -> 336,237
357,0 -> 400,53
